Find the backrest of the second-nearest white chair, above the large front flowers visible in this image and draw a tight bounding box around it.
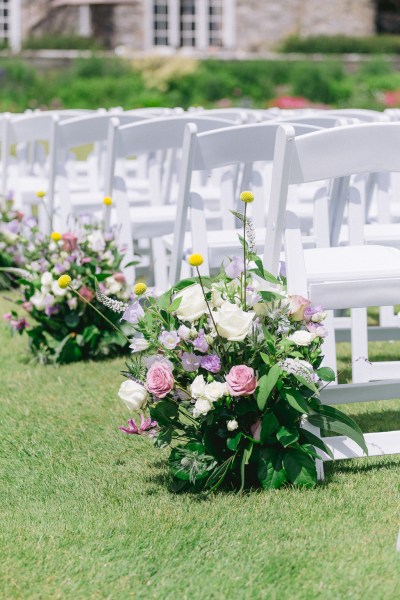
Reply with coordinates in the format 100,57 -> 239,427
170,122 -> 318,283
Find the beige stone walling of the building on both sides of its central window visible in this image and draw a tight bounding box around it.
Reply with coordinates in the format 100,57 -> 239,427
18,0 -> 376,52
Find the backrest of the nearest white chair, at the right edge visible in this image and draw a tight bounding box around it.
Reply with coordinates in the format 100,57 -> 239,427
264,122 -> 400,273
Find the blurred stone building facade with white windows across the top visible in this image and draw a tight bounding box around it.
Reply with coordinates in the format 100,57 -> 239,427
0,0 -> 384,53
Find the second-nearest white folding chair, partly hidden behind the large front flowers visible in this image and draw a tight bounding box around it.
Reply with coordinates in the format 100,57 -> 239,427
163,122 -> 318,283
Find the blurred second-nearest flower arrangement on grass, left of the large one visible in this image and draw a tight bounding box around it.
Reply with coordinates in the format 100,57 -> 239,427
5,219 -> 131,364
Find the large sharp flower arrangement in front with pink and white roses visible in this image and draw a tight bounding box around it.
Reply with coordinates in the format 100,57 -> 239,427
104,192 -> 366,491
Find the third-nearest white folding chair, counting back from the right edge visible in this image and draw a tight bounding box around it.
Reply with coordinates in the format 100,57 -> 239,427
106,114 -> 231,289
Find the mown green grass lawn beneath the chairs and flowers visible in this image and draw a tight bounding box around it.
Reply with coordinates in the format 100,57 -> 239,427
0,301 -> 400,600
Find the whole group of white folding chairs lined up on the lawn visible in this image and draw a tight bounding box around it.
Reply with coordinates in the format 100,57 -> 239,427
0,105 -> 400,476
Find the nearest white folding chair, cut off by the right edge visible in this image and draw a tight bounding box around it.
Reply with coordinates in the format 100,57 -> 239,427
264,123 -> 400,474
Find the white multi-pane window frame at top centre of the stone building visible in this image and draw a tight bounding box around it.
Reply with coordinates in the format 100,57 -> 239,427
144,0 -> 236,50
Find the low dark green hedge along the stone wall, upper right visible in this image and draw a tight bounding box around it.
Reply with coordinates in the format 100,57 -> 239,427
279,35 -> 400,54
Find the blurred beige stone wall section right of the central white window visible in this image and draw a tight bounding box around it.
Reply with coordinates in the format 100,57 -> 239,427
236,0 -> 375,51
